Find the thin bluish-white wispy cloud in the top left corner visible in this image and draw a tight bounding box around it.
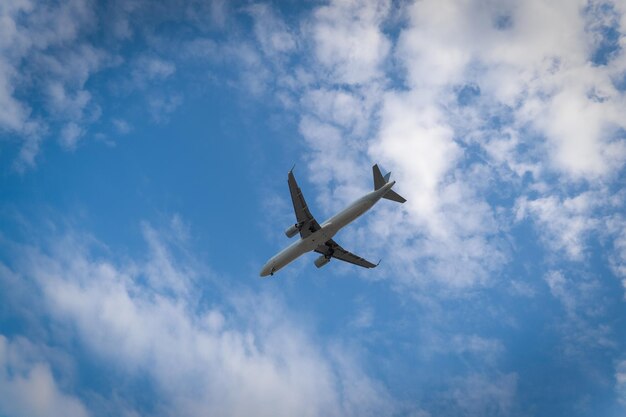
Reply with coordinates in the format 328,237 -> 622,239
0,0 -> 103,170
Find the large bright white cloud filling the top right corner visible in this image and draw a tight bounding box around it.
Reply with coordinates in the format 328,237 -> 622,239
396,0 -> 626,178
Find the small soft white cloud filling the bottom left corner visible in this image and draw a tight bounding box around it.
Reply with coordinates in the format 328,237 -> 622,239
0,334 -> 89,417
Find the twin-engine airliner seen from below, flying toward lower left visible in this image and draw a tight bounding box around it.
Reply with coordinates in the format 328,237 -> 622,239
261,165 -> 406,277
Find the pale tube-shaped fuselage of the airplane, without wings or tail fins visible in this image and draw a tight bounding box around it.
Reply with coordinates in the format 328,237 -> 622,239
261,181 -> 396,277
